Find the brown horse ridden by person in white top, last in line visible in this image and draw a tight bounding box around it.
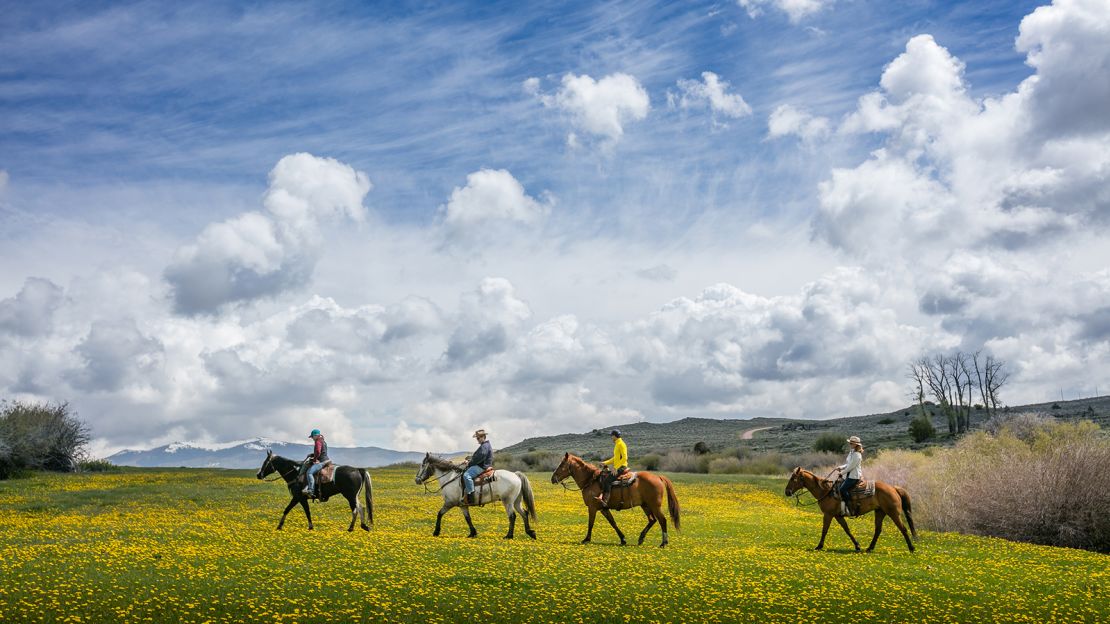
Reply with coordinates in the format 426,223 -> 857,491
786,467 -> 917,552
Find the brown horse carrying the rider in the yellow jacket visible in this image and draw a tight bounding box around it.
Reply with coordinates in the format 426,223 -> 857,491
552,453 -> 680,548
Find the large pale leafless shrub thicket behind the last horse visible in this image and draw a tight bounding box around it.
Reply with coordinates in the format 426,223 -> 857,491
868,416 -> 1110,553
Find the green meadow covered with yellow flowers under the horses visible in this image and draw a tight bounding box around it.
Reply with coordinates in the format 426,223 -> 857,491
0,464 -> 1110,623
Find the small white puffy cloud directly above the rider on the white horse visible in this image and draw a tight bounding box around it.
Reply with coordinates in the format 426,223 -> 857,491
440,169 -> 553,236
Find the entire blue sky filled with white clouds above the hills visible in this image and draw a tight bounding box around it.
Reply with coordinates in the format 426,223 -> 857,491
0,0 -> 1110,449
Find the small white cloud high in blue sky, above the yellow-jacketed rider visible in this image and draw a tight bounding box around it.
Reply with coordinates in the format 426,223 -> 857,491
524,73 -> 652,144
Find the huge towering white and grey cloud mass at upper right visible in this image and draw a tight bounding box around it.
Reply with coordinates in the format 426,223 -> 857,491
814,1 -> 1110,256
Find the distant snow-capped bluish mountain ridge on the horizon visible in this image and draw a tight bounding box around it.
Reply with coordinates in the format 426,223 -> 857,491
108,437 -> 424,469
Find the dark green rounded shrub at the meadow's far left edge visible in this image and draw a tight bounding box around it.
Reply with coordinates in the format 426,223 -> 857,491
0,401 -> 90,479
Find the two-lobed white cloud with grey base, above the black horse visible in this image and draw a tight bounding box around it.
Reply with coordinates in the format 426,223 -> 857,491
164,153 -> 371,314
